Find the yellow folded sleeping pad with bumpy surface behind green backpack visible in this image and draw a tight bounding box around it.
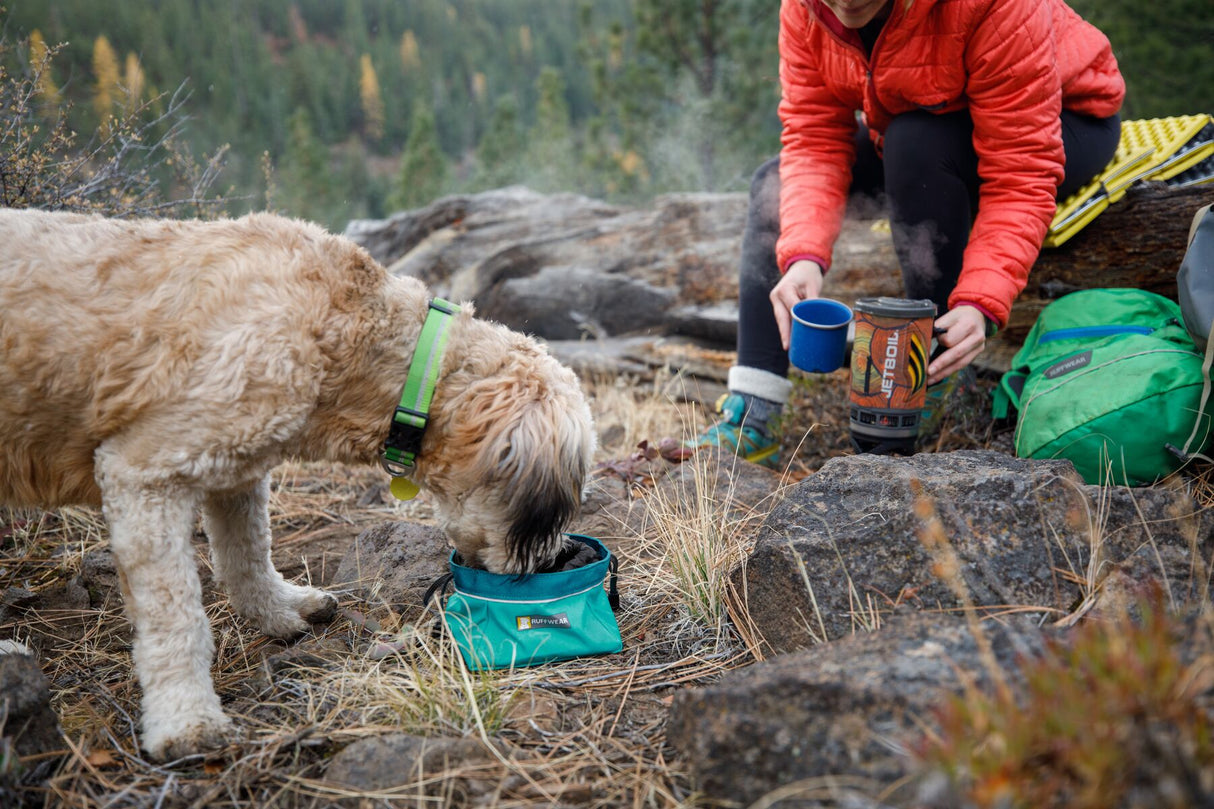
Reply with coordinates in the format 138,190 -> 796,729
1045,113 -> 1214,247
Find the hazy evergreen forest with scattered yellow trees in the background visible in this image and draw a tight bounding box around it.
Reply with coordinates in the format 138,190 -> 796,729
0,0 -> 1214,230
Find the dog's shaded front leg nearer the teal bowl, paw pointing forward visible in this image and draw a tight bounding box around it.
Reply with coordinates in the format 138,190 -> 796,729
203,477 -> 337,638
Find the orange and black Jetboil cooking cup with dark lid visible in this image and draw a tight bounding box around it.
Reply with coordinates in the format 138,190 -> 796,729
849,298 -> 936,454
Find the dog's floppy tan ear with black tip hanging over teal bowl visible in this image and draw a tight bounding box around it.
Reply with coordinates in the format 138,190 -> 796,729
501,397 -> 594,572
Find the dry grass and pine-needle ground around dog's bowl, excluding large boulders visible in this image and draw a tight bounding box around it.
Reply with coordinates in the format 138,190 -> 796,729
0,354 -> 1014,807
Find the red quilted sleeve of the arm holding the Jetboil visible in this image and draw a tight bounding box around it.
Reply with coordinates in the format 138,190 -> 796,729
949,0 -> 1063,326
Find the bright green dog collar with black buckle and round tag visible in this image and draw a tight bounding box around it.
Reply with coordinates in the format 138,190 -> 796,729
380,298 -> 459,485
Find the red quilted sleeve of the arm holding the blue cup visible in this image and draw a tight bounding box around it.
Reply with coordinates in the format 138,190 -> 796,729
776,0 -> 858,272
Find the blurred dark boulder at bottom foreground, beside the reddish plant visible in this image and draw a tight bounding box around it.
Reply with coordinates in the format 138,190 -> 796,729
666,613 -> 1043,807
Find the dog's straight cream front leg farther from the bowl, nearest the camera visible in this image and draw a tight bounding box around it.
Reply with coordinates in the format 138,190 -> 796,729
97,447 -> 234,760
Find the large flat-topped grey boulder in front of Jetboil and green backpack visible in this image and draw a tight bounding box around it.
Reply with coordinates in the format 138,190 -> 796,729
733,451 -> 1214,652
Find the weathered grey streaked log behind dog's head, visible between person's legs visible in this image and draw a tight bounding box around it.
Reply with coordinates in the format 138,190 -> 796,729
345,186 -> 901,345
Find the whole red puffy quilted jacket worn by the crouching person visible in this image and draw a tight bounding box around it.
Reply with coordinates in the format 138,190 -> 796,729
776,0 -> 1125,326
